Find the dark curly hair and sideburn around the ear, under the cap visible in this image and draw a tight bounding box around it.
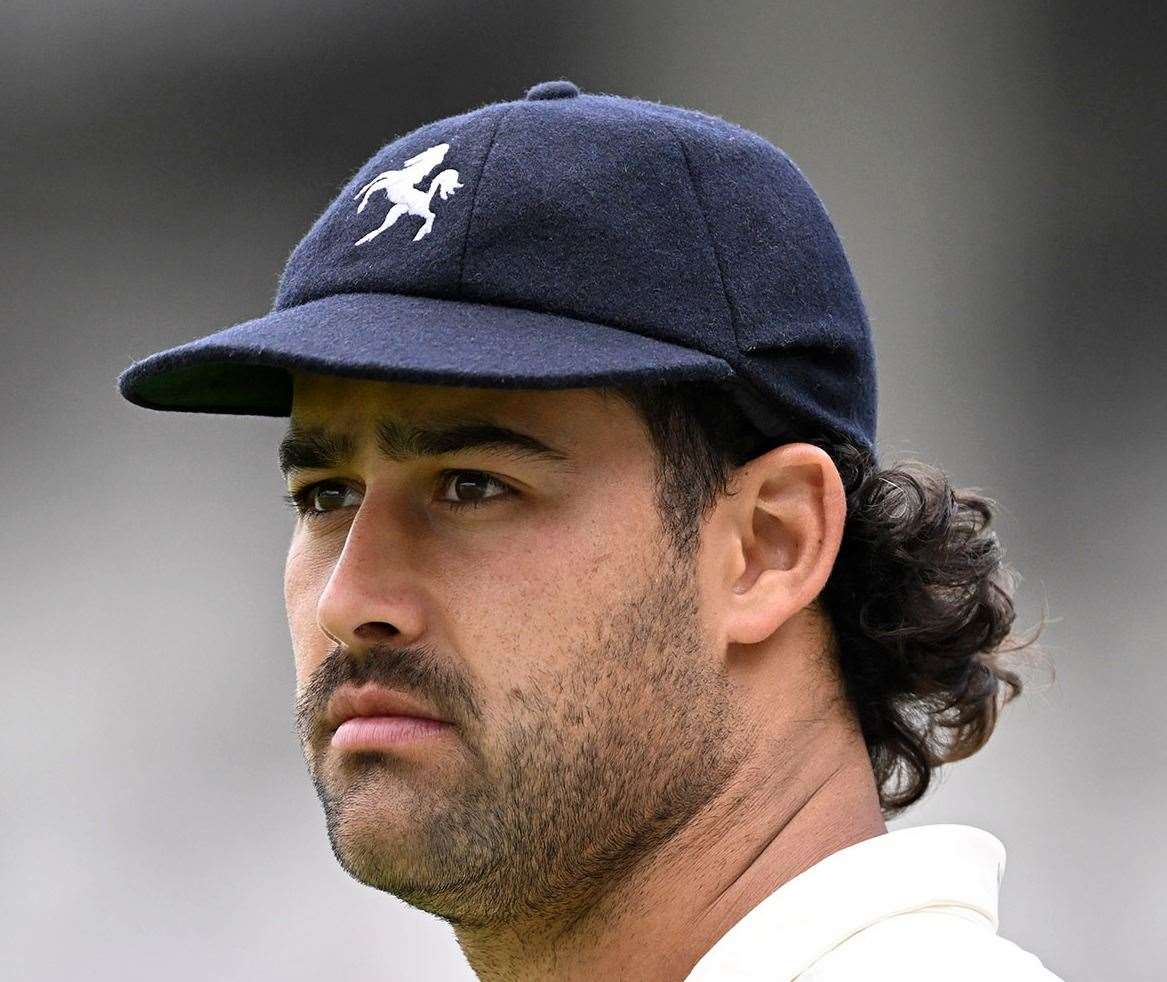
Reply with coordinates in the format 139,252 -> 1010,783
603,382 -> 1042,819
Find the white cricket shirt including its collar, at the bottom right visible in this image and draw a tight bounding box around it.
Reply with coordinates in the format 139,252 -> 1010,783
685,824 -> 1061,982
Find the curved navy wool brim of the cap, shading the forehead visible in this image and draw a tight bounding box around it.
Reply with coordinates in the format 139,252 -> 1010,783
118,293 -> 734,416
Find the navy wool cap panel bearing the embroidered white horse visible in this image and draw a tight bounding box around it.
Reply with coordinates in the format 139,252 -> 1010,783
274,103 -> 511,309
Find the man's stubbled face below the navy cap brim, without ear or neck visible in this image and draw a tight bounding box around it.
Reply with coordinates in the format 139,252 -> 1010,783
285,375 -> 742,927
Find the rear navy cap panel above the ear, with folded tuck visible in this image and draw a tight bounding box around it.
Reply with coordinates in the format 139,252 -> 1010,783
654,106 -> 876,446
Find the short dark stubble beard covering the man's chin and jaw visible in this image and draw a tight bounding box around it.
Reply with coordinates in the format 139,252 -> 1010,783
309,544 -> 743,933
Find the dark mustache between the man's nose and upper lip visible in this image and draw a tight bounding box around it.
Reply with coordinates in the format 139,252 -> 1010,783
295,645 -> 481,743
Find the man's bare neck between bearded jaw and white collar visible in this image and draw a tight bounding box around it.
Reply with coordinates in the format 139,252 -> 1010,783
455,720 -> 887,982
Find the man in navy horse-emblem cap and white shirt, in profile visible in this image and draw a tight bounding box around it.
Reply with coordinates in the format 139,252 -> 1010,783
119,79 -> 1055,982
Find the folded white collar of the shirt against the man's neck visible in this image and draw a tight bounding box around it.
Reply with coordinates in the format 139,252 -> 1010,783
685,824 -> 1005,982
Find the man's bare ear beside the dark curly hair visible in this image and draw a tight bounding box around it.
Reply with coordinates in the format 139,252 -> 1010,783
714,444 -> 847,645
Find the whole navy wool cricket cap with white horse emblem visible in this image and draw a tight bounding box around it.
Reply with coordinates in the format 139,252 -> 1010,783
118,79 -> 876,452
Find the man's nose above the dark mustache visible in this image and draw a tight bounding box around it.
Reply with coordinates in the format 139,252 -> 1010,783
316,499 -> 425,649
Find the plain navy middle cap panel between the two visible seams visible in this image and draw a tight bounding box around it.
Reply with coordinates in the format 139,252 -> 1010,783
462,95 -> 734,355
